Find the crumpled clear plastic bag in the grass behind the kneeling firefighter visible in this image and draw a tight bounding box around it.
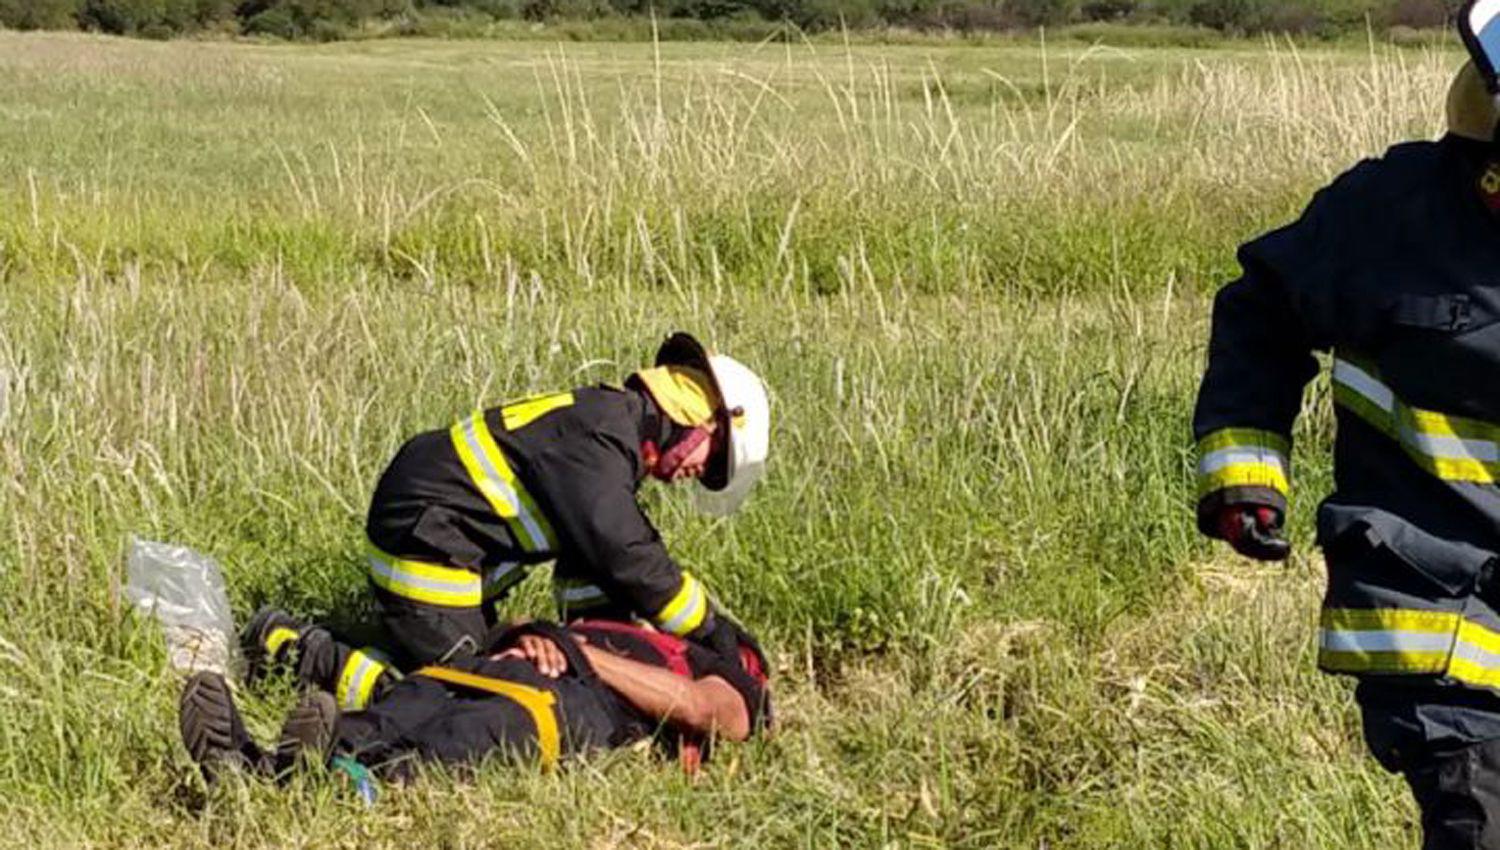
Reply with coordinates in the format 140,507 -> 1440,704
120,537 -> 234,675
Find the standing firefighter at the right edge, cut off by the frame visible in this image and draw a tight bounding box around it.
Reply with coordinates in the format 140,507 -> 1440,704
1194,0 -> 1500,850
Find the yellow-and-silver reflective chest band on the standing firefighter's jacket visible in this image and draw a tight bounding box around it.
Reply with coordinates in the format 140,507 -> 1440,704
1334,355 -> 1500,484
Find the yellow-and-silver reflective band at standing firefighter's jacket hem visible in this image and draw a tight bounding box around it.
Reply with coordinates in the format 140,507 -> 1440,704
1319,609 -> 1500,688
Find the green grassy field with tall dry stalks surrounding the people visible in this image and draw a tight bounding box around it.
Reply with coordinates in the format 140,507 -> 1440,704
0,33 -> 1458,849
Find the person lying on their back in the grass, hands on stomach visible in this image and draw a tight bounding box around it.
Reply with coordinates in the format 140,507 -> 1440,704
179,621 -> 771,780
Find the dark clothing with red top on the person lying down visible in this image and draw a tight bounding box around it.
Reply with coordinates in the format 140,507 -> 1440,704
335,621 -> 768,777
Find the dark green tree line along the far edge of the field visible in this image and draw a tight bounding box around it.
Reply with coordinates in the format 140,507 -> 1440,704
0,0 -> 1457,40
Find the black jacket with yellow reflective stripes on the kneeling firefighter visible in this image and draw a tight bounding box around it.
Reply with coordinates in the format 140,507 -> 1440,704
366,387 -> 710,636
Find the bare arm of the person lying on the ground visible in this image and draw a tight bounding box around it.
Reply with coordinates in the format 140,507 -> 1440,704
582,643 -> 750,741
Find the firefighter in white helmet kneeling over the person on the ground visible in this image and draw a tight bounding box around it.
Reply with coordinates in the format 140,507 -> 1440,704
246,333 -> 770,711
